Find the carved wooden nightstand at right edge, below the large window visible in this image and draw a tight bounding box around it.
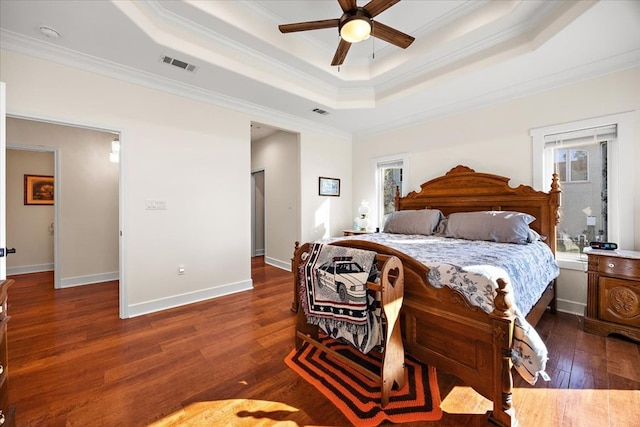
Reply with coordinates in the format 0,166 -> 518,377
584,249 -> 640,341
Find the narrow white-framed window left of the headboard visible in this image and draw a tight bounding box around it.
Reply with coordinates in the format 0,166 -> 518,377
376,155 -> 408,228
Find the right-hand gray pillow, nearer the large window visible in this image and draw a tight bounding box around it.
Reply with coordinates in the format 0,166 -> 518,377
438,211 -> 535,244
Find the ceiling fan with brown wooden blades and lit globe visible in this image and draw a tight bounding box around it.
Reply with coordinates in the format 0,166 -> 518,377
278,0 -> 415,66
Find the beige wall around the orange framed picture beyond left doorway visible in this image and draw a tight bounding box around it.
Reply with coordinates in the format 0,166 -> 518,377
6,149 -> 54,275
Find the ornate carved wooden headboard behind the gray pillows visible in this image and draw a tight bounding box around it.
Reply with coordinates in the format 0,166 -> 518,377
395,165 -> 560,253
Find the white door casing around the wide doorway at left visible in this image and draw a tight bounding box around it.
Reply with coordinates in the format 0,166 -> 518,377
4,112 -> 129,319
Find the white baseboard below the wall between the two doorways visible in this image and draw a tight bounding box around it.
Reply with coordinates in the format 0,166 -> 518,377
127,280 -> 253,317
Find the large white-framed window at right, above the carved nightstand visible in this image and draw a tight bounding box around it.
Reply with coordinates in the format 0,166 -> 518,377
531,113 -> 635,269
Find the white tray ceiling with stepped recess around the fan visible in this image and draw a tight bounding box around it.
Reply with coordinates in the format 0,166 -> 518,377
0,0 -> 640,138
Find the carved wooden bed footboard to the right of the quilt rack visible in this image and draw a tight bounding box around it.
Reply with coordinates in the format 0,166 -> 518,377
322,240 -> 515,426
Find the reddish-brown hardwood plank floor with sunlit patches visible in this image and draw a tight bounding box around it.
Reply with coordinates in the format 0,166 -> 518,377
8,258 -> 640,427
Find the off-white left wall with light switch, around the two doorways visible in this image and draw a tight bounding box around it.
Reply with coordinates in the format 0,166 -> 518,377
0,50 -> 351,317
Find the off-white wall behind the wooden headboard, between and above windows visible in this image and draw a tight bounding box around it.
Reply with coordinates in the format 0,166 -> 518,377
352,68 -> 640,314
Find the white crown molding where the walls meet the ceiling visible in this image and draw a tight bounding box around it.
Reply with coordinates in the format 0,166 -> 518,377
5,30 -> 640,145
